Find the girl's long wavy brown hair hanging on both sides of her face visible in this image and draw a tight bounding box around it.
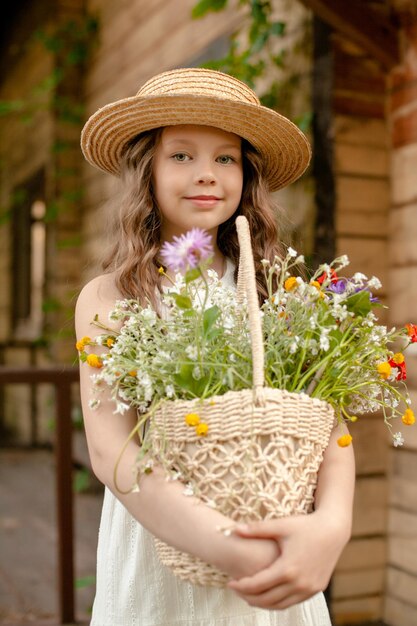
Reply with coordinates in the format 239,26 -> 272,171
103,128 -> 288,309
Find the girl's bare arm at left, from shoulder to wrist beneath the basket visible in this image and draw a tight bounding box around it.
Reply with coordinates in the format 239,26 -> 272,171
76,275 -> 278,579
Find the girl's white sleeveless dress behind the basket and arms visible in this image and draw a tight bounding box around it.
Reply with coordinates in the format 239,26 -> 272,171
90,262 -> 331,626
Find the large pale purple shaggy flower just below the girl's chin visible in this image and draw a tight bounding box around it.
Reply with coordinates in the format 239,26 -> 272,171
161,228 -> 213,271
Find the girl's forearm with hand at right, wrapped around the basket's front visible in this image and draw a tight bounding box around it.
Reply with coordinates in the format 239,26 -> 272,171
229,429 -> 355,609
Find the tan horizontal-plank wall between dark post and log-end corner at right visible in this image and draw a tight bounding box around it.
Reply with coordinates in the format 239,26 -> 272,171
332,28 -> 390,624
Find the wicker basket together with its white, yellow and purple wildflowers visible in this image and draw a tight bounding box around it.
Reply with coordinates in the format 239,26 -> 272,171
78,218 -> 417,585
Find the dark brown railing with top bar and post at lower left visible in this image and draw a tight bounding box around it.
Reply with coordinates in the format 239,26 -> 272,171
0,366 -> 79,624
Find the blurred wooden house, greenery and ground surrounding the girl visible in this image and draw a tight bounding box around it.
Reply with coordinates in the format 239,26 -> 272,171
0,0 -> 417,626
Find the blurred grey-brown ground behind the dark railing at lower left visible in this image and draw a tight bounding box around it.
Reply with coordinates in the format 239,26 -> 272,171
0,449 -> 102,625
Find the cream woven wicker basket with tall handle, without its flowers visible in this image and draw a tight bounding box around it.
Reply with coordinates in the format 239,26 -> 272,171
152,217 -> 334,587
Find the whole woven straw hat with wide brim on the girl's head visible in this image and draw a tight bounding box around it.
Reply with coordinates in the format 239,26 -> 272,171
81,68 -> 311,191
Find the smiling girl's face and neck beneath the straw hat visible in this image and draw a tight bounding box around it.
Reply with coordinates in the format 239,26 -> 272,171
153,125 -> 243,241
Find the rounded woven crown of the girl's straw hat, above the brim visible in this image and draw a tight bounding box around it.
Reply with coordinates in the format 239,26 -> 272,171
136,68 -> 261,106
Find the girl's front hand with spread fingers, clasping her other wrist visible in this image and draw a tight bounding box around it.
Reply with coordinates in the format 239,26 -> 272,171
228,511 -> 350,609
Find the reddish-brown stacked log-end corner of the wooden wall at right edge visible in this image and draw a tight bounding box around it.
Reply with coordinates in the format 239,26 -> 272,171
384,12 -> 417,626
